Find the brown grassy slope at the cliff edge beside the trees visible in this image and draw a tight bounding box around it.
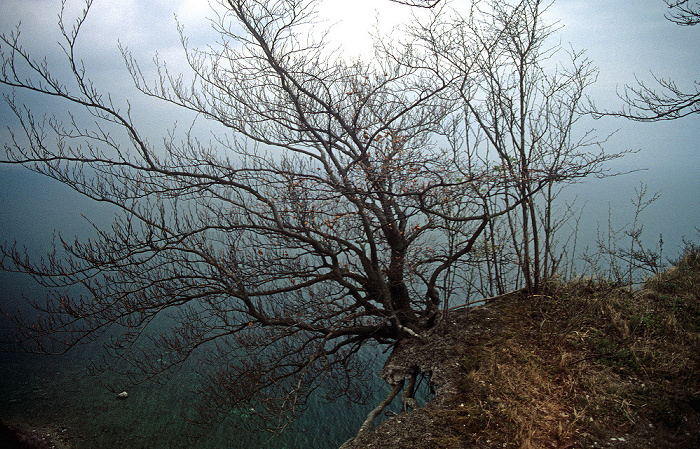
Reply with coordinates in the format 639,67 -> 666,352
350,248 -> 700,448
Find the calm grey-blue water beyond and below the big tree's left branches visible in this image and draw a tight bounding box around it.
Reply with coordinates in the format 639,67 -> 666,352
0,170 -> 396,449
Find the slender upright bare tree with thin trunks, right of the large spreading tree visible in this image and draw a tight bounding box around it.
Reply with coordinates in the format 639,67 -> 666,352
404,0 -> 623,295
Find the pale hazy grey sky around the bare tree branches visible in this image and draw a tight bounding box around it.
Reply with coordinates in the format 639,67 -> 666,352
0,0 -> 700,260
